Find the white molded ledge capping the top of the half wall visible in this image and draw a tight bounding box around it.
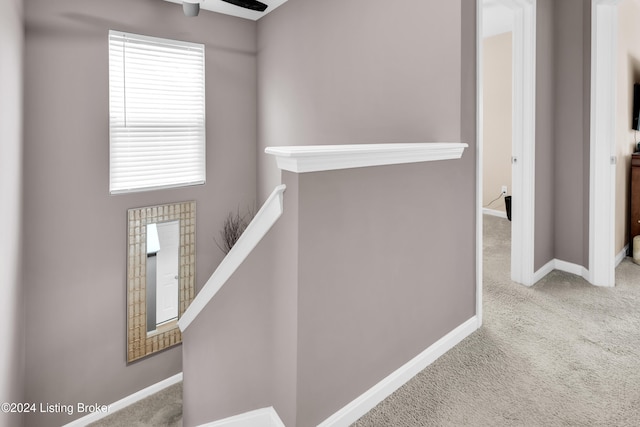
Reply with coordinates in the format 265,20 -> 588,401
264,142 -> 469,173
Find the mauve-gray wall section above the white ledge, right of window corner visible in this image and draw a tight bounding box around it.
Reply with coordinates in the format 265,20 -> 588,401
258,0 -> 468,200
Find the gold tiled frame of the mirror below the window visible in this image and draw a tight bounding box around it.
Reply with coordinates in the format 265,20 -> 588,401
127,201 -> 196,363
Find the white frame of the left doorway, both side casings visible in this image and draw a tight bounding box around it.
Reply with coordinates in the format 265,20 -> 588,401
476,0 -> 536,323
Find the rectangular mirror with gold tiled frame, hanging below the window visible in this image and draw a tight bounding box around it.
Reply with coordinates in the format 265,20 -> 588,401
127,201 -> 196,362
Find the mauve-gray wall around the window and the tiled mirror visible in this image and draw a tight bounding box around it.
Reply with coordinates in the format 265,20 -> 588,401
22,0 -> 257,426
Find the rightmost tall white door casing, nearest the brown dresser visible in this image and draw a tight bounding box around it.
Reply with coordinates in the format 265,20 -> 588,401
587,0 -> 619,286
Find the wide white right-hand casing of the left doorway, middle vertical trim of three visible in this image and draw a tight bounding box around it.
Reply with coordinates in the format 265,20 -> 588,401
511,0 -> 536,286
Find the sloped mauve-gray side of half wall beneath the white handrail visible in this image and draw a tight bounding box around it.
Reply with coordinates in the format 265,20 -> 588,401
183,180 -> 298,426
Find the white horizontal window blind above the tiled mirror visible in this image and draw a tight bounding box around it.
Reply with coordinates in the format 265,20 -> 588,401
109,31 -> 206,194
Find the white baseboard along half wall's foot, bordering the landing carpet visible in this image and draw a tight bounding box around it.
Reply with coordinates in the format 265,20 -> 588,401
318,316 -> 480,427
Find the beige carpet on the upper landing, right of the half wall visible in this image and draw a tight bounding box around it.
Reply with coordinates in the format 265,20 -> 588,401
355,216 -> 640,427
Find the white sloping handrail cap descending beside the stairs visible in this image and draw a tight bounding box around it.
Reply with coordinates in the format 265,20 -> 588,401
178,185 -> 287,332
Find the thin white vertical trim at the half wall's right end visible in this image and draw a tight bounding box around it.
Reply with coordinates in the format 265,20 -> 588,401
476,0 -> 484,327
